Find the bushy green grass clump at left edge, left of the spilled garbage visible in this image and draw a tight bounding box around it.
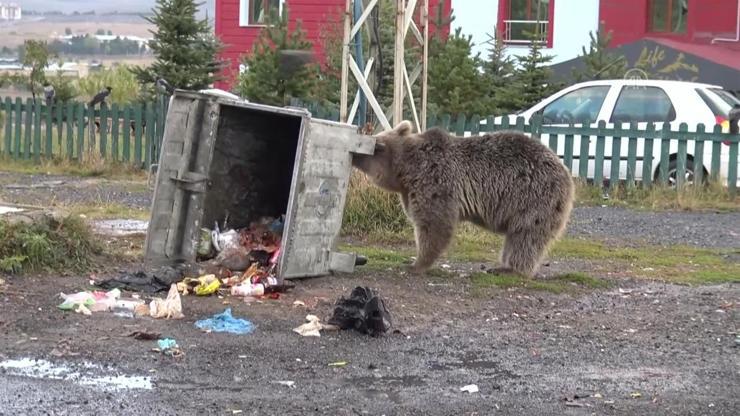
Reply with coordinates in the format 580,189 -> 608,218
0,216 -> 102,273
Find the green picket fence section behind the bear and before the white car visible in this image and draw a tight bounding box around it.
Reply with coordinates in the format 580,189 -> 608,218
291,100 -> 740,196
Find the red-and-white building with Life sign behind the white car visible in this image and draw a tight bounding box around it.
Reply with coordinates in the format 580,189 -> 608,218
452,0 -> 740,90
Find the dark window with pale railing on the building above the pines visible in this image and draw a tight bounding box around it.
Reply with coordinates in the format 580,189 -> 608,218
504,0 -> 551,44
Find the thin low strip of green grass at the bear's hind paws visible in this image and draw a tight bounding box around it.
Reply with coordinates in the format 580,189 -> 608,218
471,273 -> 609,294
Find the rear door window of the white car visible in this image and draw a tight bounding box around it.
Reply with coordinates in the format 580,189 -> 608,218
610,85 -> 676,123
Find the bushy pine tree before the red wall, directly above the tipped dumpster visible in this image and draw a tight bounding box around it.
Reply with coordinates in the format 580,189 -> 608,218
236,7 -> 318,106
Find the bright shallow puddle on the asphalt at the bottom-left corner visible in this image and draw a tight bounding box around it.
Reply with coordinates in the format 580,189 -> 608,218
0,358 -> 153,390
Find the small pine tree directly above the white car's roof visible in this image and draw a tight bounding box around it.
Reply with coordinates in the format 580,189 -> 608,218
573,25 -> 627,82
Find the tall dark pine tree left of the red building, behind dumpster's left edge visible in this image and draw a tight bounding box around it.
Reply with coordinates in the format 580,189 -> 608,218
134,0 -> 223,90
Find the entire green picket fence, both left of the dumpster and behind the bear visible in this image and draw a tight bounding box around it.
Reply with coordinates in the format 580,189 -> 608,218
5,96 -> 740,196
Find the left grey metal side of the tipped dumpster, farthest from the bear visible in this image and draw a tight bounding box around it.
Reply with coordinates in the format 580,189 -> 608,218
145,93 -> 219,263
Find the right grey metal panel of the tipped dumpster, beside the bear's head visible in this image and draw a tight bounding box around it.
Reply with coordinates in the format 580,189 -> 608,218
280,120 -> 358,279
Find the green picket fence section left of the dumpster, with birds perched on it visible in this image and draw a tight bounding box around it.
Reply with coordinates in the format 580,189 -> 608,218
0,97 -> 169,167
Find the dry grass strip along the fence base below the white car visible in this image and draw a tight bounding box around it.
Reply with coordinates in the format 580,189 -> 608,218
576,181 -> 740,211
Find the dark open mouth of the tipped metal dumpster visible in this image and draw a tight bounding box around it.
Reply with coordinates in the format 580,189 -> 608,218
203,106 -> 302,232
